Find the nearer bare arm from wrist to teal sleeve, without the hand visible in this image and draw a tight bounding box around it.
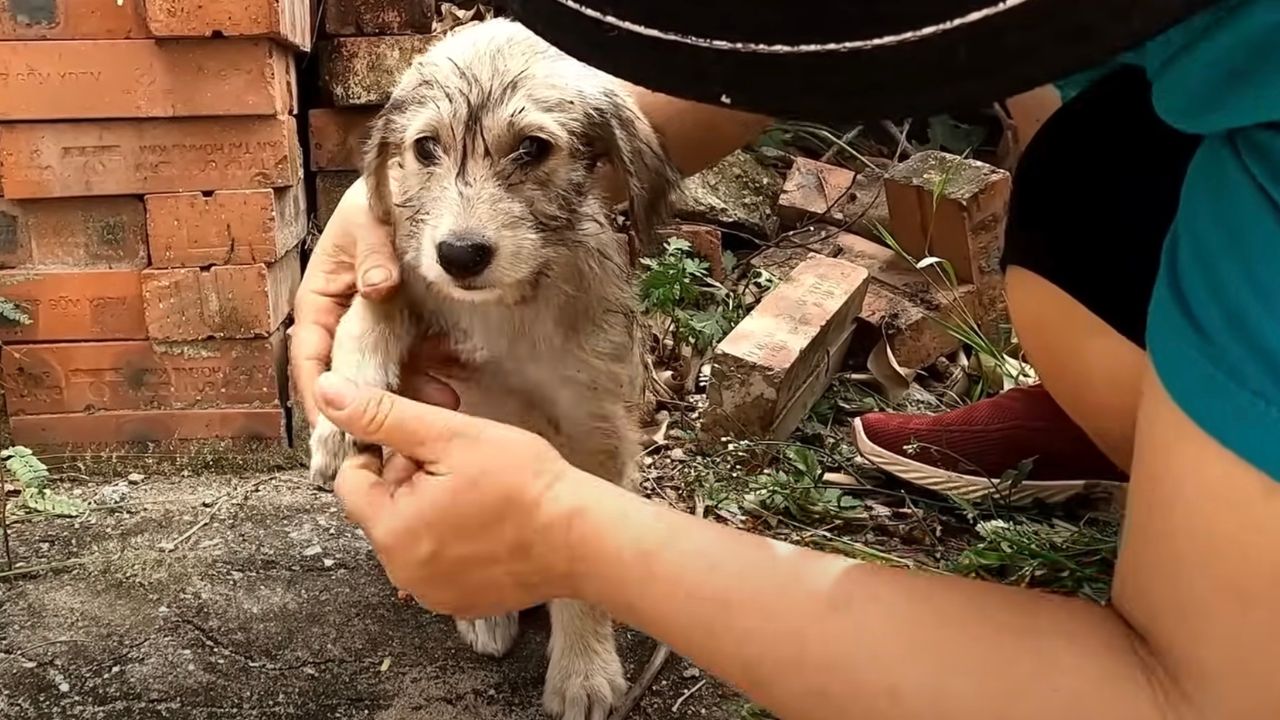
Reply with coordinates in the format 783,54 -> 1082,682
566,363 -> 1280,720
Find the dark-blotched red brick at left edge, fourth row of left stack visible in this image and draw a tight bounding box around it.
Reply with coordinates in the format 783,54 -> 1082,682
0,197 -> 147,269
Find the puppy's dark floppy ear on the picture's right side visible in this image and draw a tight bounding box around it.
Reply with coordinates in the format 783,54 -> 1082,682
591,90 -> 682,255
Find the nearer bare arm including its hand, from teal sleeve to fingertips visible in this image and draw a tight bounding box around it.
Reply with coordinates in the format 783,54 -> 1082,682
321,361 -> 1280,720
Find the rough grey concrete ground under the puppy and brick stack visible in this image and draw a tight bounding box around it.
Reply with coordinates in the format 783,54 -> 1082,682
0,475 -> 745,720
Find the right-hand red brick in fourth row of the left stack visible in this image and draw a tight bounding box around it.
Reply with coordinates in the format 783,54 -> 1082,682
146,186 -> 307,268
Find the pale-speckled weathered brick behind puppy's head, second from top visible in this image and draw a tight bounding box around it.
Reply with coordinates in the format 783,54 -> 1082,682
317,35 -> 436,108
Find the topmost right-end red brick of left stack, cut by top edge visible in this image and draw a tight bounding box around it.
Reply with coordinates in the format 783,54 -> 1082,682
144,0 -> 314,50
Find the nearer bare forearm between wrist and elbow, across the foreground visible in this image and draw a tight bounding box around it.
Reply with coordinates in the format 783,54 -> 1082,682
560,471 -> 1177,720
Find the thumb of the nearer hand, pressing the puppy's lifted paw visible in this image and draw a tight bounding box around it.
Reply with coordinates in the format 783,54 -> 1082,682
316,373 -> 480,464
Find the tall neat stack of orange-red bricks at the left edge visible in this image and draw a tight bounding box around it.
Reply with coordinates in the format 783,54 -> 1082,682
0,0 -> 311,447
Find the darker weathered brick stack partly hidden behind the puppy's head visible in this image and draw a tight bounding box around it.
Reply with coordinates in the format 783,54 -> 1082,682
307,0 -> 463,225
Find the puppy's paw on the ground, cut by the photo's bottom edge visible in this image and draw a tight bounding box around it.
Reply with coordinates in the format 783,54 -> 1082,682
543,648 -> 627,720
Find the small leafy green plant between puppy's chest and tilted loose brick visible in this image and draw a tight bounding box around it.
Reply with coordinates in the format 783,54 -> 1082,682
640,238 -> 777,355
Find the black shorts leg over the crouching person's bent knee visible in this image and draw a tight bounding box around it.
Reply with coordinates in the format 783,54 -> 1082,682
1001,68 -> 1201,348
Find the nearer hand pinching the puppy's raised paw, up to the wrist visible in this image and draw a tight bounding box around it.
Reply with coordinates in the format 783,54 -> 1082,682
316,366 -> 601,618
